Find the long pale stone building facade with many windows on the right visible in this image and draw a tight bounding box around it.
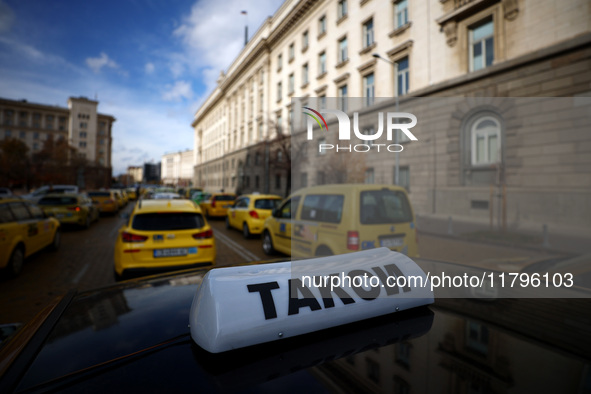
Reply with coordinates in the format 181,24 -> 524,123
192,0 -> 591,228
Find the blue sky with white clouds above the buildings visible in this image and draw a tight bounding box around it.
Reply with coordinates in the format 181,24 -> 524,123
0,0 -> 282,175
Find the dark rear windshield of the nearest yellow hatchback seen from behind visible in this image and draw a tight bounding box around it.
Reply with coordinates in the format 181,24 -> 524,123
131,212 -> 205,231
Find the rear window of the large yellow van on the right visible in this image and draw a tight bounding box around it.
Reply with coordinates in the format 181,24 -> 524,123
359,189 -> 412,224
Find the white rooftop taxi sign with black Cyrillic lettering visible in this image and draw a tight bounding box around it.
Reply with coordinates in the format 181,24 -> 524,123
189,248 -> 433,353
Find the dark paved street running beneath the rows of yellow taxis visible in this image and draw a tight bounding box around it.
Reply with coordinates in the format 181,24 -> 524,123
0,203 -> 556,324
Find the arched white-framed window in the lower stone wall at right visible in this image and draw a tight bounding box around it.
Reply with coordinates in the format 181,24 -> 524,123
470,116 -> 501,166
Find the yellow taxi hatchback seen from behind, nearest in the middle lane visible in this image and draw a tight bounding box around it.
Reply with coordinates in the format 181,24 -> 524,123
115,200 -> 216,279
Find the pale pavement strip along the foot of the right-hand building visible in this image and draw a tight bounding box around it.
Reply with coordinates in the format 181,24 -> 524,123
417,214 -> 591,255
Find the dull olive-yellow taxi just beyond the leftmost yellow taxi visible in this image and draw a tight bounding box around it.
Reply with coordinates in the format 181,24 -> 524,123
38,193 -> 99,228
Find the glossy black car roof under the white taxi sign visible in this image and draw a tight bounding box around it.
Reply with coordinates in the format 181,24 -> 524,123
0,264 -> 591,393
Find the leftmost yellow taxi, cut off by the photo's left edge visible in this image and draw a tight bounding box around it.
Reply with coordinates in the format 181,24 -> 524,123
0,199 -> 60,276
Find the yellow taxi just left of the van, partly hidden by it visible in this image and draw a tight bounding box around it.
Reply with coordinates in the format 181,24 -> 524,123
226,194 -> 282,238
